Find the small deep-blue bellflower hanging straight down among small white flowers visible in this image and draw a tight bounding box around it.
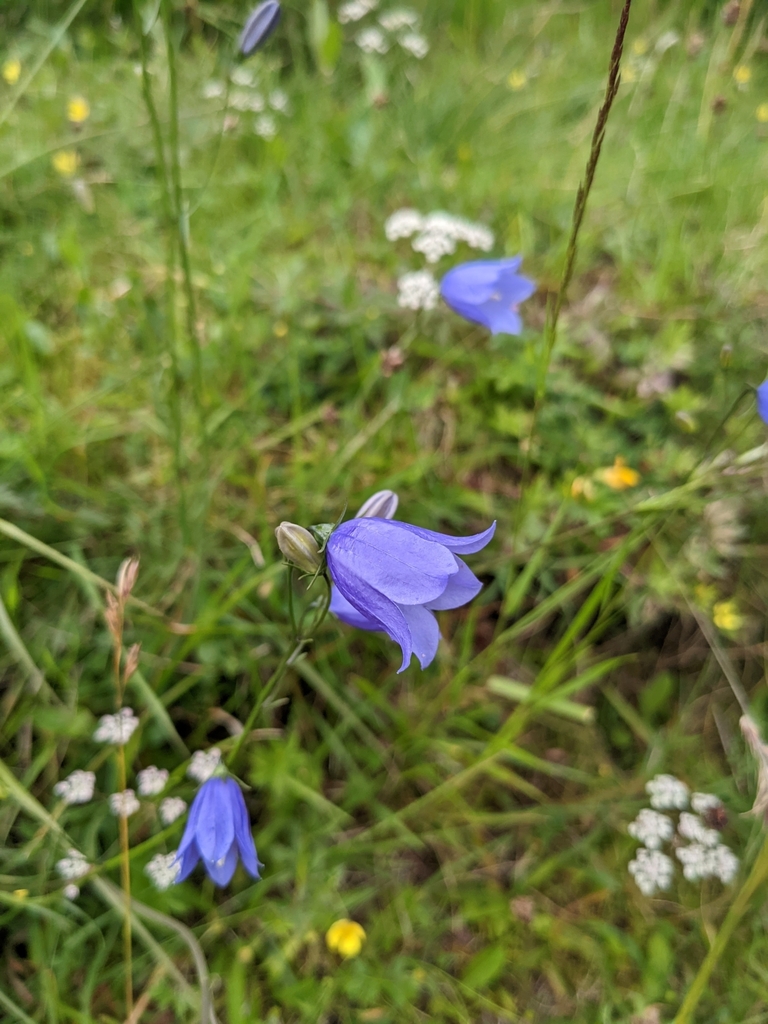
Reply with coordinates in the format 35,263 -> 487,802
176,776 -> 259,886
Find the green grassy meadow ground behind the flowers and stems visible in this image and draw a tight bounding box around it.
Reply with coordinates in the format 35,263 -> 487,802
0,0 -> 768,1024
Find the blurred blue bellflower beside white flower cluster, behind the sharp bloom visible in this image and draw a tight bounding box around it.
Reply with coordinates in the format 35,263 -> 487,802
440,256 -> 536,334
